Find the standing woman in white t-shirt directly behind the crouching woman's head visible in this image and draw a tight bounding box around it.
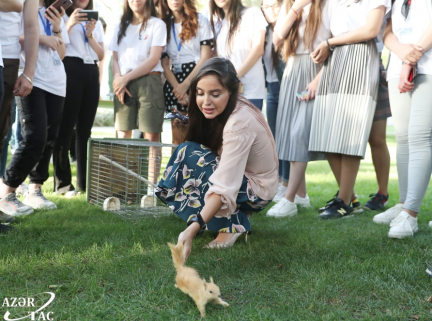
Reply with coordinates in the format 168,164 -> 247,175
210,0 -> 267,110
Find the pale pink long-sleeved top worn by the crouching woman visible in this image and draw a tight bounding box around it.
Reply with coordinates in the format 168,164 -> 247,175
205,96 -> 279,217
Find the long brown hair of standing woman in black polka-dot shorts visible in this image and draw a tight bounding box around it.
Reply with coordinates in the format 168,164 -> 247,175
158,0 -> 198,43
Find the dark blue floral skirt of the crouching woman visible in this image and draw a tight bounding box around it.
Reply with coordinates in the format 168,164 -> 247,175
156,142 -> 270,233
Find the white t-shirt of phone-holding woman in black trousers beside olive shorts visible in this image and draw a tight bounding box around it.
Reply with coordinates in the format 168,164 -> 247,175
63,15 -> 104,61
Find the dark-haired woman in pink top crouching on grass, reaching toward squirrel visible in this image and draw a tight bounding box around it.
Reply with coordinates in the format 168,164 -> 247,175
156,58 -> 278,257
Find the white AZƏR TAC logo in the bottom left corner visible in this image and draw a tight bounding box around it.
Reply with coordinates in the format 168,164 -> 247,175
2,292 -> 55,321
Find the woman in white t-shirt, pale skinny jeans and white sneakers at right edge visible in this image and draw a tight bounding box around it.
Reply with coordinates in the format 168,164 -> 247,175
373,0 -> 432,238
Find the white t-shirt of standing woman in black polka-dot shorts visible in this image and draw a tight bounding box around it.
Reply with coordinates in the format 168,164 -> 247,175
166,13 -> 213,64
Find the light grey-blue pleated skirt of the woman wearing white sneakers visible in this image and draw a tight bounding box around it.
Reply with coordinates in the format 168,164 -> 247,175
276,55 -> 324,163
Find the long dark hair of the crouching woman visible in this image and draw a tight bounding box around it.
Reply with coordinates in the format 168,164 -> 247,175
185,57 -> 240,154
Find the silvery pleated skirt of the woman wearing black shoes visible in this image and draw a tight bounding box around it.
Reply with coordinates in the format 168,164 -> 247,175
309,40 -> 380,158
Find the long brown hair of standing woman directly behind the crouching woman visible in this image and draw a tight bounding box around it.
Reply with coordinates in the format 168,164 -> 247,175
209,0 -> 246,52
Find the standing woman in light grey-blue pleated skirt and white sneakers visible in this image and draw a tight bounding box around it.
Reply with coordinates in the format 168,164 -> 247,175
267,0 -> 335,217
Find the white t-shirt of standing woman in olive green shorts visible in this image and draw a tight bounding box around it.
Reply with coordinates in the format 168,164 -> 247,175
109,17 -> 167,75
